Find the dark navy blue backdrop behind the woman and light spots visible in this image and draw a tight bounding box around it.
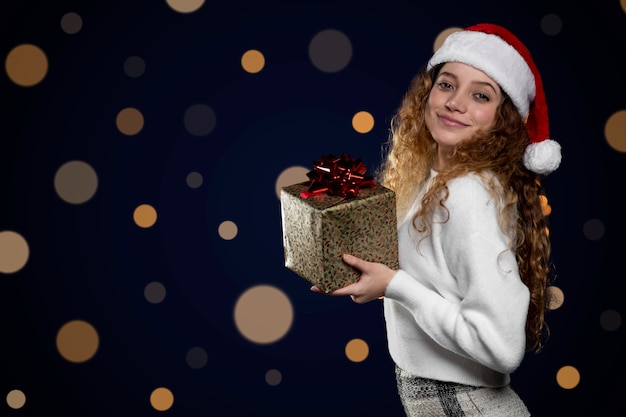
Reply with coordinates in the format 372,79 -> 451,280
0,0 -> 626,417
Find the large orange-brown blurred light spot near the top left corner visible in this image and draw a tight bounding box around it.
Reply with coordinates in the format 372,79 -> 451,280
5,44 -> 48,87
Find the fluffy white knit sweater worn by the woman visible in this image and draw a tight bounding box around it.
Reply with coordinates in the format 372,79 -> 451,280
384,170 -> 529,387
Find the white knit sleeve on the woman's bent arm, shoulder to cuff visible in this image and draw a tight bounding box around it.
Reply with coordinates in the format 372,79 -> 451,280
385,177 -> 529,374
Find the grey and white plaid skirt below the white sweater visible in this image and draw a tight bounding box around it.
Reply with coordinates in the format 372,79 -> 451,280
396,366 -> 530,417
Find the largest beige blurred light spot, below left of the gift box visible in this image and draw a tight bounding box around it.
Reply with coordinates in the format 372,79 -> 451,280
234,285 -> 293,344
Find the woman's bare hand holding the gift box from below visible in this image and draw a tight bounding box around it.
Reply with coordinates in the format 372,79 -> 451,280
311,254 -> 396,304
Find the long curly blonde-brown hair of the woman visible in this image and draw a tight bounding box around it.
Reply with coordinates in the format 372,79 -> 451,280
377,65 -> 553,352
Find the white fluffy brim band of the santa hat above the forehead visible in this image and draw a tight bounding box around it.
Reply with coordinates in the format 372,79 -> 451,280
428,30 -> 535,118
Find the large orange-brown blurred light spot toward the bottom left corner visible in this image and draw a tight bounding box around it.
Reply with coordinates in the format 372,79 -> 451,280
56,320 -> 100,363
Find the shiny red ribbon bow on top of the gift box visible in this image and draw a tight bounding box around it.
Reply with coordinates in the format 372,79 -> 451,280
300,153 -> 376,198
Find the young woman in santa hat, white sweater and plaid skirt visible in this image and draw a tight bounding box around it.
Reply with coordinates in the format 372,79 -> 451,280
312,24 -> 561,417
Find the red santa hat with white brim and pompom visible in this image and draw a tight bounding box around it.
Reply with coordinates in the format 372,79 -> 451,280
428,23 -> 561,174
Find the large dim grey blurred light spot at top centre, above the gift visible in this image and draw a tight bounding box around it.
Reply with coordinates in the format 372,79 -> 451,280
309,29 -> 352,72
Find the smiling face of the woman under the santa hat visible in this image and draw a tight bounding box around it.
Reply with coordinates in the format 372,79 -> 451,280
425,62 -> 502,150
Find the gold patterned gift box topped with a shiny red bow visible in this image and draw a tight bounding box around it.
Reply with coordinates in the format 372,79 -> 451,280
280,154 -> 398,293
